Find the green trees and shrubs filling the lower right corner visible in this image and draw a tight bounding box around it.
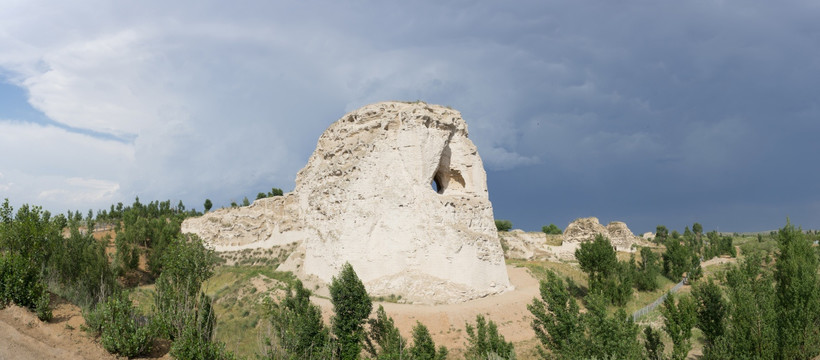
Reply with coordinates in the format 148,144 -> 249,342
528,223 -> 820,359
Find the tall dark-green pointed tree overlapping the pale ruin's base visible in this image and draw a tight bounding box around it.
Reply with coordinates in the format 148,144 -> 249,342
330,263 -> 373,360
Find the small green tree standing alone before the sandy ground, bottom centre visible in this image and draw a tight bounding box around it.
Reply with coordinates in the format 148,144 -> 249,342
465,314 -> 515,360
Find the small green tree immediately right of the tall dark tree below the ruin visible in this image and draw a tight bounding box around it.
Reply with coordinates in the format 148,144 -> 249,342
365,305 -> 409,360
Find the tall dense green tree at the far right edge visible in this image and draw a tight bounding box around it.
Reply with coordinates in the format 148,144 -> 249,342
774,222 -> 820,359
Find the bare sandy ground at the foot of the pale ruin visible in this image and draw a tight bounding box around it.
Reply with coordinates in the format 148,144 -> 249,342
313,265 -> 539,359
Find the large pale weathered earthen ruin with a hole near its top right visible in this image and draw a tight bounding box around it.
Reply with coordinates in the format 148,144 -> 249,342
183,102 -> 510,302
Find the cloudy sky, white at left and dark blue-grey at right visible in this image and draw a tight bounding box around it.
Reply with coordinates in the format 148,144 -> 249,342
0,0 -> 820,233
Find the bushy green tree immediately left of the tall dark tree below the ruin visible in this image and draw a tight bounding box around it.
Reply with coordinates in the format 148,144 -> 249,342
266,280 -> 330,360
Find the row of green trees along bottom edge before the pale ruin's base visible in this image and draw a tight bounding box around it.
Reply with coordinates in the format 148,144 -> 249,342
265,264 -> 515,360
